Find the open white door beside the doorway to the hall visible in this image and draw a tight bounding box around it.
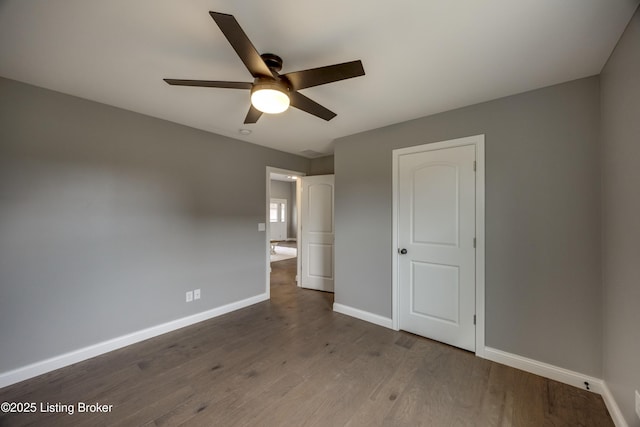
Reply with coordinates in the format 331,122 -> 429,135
299,175 -> 334,292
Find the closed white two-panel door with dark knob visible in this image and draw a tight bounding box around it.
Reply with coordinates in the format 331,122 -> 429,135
397,145 -> 476,351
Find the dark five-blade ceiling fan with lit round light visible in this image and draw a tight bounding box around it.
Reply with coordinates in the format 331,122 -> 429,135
164,12 -> 364,123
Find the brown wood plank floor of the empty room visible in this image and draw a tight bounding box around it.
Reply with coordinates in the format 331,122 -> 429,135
0,259 -> 613,427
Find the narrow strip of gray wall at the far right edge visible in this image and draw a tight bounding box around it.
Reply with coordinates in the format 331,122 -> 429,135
601,5 -> 640,426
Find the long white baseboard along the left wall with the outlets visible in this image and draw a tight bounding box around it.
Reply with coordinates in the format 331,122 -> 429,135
0,293 -> 269,388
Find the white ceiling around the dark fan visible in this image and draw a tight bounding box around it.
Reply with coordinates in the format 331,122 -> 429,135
0,0 -> 640,159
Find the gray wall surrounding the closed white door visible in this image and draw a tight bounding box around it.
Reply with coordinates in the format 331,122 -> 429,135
335,77 -> 602,377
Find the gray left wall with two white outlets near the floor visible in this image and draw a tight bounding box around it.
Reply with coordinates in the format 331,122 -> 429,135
0,79 -> 309,372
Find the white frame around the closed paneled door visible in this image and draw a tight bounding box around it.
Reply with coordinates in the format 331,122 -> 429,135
391,135 -> 485,357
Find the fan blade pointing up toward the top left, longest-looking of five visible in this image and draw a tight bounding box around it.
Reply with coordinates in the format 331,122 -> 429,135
209,12 -> 275,77
